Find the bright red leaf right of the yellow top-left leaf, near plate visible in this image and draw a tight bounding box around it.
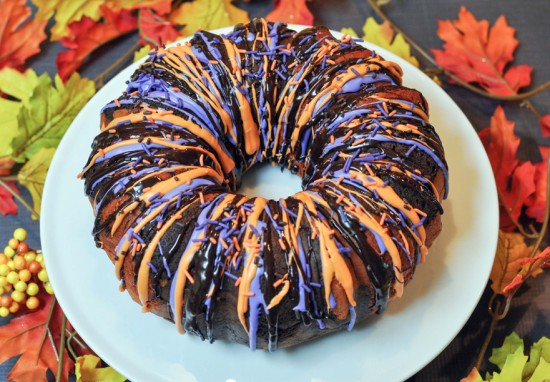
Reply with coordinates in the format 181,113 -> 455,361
56,6 -> 137,81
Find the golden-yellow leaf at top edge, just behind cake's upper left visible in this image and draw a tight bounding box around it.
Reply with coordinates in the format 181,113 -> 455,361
168,0 -> 250,40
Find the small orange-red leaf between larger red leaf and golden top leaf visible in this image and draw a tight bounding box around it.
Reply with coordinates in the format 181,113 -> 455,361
139,8 -> 180,46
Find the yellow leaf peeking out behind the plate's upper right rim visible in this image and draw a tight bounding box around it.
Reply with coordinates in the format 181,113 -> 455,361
342,17 -> 418,67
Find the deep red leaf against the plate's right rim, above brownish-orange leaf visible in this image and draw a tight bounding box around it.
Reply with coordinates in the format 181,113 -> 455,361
479,106 -> 536,228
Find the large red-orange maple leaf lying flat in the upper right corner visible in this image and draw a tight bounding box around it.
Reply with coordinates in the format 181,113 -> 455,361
432,7 -> 532,95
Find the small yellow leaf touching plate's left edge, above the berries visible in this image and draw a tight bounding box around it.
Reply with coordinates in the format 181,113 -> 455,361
17,148 -> 55,218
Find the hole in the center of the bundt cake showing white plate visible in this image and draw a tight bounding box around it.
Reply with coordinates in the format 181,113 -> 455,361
238,163 -> 302,200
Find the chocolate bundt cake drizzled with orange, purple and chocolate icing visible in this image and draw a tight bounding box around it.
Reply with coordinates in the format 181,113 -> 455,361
81,19 -> 448,351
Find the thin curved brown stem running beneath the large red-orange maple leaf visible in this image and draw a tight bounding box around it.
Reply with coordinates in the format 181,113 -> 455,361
368,0 -> 550,101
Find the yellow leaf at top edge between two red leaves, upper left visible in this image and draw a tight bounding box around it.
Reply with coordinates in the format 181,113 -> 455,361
32,0 -> 104,41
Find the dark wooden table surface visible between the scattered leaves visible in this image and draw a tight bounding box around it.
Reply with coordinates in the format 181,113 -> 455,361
0,0 -> 550,381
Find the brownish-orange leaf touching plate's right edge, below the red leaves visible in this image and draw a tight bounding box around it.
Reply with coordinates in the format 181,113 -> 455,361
489,230 -> 542,295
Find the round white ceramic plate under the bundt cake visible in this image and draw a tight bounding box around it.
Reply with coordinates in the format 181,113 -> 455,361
41,26 -> 498,382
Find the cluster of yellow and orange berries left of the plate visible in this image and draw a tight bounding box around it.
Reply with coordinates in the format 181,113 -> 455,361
0,228 -> 53,317
